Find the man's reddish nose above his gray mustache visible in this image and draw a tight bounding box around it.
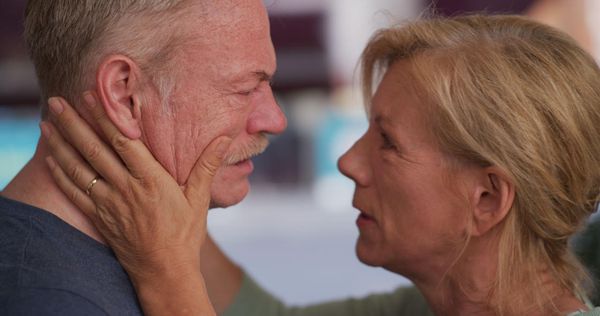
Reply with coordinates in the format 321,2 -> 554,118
248,91 -> 287,134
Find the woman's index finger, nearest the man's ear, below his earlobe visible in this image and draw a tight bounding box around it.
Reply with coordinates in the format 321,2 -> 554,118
84,91 -> 164,179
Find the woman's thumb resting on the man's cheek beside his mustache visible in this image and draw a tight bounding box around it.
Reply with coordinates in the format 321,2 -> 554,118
185,136 -> 231,210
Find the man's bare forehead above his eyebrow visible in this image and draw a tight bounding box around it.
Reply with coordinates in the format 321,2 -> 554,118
173,0 -> 276,93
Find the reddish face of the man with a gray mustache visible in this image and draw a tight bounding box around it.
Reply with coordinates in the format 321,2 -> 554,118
141,0 -> 287,207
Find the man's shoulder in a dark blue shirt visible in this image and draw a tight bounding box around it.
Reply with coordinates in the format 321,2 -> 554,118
0,198 -> 141,315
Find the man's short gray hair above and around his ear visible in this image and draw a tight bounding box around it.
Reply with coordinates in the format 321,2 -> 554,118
25,0 -> 187,116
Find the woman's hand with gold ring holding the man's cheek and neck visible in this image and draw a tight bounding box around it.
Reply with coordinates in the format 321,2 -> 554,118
41,92 -> 231,313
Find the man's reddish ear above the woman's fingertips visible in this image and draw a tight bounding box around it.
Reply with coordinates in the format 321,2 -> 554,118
96,55 -> 142,139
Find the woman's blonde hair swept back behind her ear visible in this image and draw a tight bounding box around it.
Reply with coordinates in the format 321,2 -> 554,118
362,15 -> 600,314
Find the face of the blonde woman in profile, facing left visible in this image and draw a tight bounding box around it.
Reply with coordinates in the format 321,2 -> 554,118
338,61 -> 468,277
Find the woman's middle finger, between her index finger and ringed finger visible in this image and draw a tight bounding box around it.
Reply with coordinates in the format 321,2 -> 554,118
48,97 -> 128,186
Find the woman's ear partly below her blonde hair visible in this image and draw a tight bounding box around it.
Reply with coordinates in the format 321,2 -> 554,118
471,167 -> 515,236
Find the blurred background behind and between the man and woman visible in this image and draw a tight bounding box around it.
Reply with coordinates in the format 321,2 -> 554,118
0,0 -> 600,304
